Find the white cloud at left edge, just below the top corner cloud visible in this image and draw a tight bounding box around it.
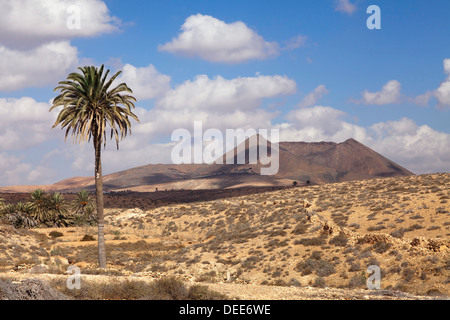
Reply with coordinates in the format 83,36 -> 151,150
0,41 -> 78,91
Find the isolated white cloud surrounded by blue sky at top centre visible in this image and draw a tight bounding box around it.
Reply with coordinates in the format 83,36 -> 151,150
158,14 -> 279,63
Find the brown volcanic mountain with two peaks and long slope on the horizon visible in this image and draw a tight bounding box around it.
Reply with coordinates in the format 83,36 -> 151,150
0,138 -> 413,192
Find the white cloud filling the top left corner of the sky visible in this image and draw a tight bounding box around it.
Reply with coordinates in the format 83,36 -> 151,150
0,0 -> 119,49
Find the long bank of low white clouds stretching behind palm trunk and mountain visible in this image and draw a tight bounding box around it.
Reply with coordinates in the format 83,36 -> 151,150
67,70 -> 450,178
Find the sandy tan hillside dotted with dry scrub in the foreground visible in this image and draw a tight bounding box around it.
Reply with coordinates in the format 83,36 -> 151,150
0,174 -> 450,299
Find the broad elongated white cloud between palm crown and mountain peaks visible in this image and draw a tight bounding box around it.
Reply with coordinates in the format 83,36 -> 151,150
134,75 -> 296,136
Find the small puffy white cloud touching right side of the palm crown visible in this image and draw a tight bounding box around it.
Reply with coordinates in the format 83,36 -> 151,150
116,64 -> 171,100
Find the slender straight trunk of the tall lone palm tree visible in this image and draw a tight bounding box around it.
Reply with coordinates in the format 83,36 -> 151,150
94,131 -> 106,269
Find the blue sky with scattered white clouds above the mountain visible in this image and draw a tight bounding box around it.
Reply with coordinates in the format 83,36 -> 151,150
0,0 -> 450,186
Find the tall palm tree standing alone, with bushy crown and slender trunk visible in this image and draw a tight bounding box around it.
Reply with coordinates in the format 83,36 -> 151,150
50,65 -> 139,269
